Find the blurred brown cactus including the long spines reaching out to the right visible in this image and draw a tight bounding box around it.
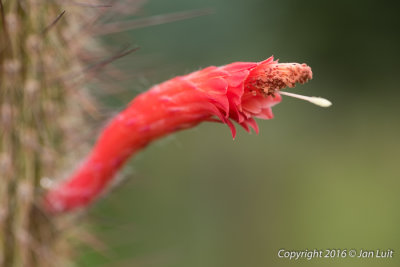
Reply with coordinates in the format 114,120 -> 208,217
0,0 -> 216,267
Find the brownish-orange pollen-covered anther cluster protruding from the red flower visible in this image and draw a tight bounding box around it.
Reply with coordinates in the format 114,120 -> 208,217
248,62 -> 312,95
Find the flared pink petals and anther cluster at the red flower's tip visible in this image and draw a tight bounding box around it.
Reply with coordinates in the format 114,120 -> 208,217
211,57 -> 312,138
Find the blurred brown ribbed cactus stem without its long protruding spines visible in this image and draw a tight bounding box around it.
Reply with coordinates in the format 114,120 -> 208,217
0,0 -> 93,266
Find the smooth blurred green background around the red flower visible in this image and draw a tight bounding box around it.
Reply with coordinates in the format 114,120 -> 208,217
79,0 -> 400,267
